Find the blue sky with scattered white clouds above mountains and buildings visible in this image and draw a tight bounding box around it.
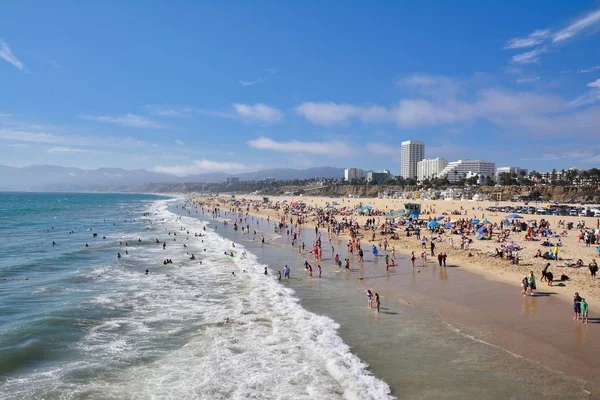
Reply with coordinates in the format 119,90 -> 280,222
0,1 -> 600,175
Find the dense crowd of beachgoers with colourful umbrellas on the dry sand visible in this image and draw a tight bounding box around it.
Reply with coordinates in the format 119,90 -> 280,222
198,198 -> 600,324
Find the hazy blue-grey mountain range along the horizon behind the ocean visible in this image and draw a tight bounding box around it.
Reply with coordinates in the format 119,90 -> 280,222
0,164 -> 344,191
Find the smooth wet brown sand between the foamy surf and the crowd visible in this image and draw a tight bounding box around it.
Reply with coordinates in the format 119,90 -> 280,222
199,208 -> 600,399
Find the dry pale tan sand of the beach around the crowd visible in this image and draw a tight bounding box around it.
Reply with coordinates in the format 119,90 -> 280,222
198,195 -> 600,304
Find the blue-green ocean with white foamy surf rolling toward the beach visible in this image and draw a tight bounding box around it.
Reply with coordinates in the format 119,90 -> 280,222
0,193 -> 393,399
